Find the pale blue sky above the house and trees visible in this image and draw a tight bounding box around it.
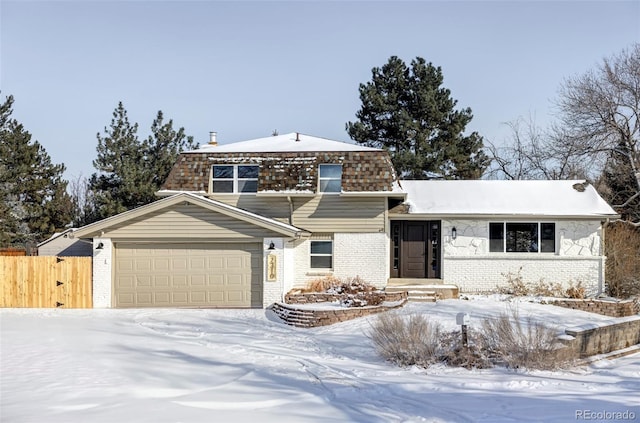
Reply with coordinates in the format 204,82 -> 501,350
0,0 -> 640,180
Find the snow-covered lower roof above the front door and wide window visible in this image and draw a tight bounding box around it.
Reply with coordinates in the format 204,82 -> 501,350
400,180 -> 618,218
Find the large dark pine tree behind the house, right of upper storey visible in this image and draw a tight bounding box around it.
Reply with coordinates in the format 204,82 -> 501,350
346,56 -> 489,179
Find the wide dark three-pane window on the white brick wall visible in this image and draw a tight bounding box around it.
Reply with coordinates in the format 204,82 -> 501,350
489,222 -> 556,253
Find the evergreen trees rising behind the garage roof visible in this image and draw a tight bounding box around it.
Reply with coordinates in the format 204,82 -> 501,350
87,102 -> 194,222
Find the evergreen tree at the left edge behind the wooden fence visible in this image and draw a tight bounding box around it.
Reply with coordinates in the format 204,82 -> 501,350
0,96 -> 71,243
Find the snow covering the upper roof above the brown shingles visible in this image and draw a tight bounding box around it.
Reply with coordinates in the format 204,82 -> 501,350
188,132 -> 382,153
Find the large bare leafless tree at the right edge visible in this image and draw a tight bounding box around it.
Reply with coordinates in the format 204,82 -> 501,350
556,43 -> 640,221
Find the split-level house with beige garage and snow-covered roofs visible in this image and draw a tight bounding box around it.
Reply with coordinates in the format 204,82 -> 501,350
74,133 -> 617,307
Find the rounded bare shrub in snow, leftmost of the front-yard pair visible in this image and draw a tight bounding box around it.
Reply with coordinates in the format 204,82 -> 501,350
369,312 -> 441,367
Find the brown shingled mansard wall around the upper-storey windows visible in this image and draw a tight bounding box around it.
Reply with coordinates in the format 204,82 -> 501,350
162,151 -> 397,193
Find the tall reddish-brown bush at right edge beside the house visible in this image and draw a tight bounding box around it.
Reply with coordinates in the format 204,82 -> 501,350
605,221 -> 640,298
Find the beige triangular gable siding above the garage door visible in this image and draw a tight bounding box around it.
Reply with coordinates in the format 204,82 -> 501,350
103,204 -> 281,240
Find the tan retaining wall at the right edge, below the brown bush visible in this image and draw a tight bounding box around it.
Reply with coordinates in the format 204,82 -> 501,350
565,317 -> 640,357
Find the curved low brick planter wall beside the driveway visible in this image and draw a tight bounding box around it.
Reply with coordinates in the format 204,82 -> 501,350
270,295 -> 407,328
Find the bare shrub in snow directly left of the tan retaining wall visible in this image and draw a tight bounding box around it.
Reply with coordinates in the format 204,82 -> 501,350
480,310 -> 575,370
